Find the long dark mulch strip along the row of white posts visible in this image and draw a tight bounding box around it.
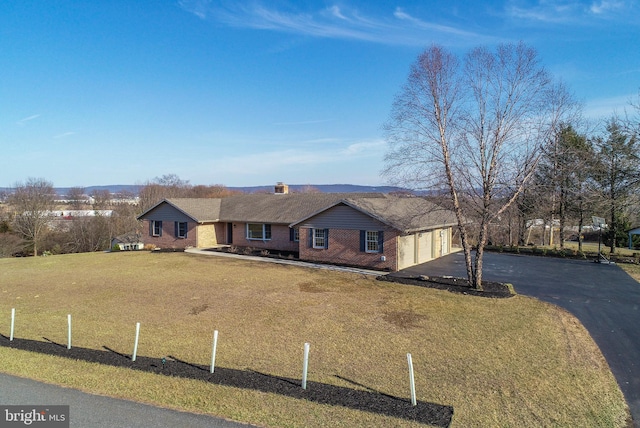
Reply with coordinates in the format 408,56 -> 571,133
0,335 -> 453,427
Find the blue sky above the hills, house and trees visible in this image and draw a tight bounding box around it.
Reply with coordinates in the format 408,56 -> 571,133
0,0 -> 640,187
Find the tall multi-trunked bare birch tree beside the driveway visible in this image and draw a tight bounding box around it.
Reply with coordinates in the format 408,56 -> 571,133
383,43 -> 551,289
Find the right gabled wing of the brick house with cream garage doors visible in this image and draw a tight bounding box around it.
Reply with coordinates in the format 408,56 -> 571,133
290,197 -> 457,271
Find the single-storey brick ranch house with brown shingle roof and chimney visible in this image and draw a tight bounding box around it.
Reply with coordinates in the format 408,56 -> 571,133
138,185 -> 457,271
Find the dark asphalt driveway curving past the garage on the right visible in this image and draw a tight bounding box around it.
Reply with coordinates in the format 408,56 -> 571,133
394,253 -> 640,426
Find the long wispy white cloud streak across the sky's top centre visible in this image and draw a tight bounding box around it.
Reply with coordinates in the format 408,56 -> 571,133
180,0 -> 494,45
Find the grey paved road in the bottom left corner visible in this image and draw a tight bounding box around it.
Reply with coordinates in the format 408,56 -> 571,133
0,373 -> 255,428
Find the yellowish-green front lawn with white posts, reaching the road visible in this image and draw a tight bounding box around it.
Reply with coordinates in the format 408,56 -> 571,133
0,252 -> 629,427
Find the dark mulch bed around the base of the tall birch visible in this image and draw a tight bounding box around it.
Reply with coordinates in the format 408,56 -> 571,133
376,275 -> 515,299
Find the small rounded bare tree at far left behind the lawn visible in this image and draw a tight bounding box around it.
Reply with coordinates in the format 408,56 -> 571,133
9,178 -> 55,256
